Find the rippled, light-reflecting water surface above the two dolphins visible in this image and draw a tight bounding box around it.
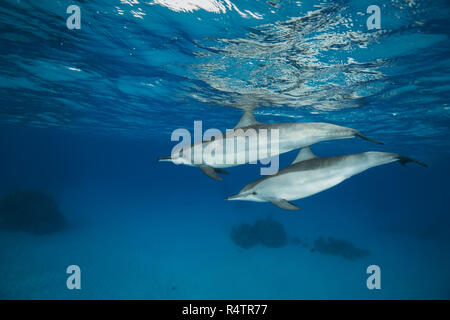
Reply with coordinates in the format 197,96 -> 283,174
0,0 -> 450,142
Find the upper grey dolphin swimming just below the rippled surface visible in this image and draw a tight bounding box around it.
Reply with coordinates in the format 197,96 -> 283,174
158,110 -> 383,180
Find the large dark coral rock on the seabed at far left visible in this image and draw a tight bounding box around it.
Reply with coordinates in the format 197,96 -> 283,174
0,190 -> 66,234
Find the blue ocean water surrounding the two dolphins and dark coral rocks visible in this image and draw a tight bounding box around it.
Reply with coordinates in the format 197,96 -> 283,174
0,0 -> 450,299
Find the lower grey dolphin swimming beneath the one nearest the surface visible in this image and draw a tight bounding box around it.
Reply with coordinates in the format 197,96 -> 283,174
225,147 -> 427,210
